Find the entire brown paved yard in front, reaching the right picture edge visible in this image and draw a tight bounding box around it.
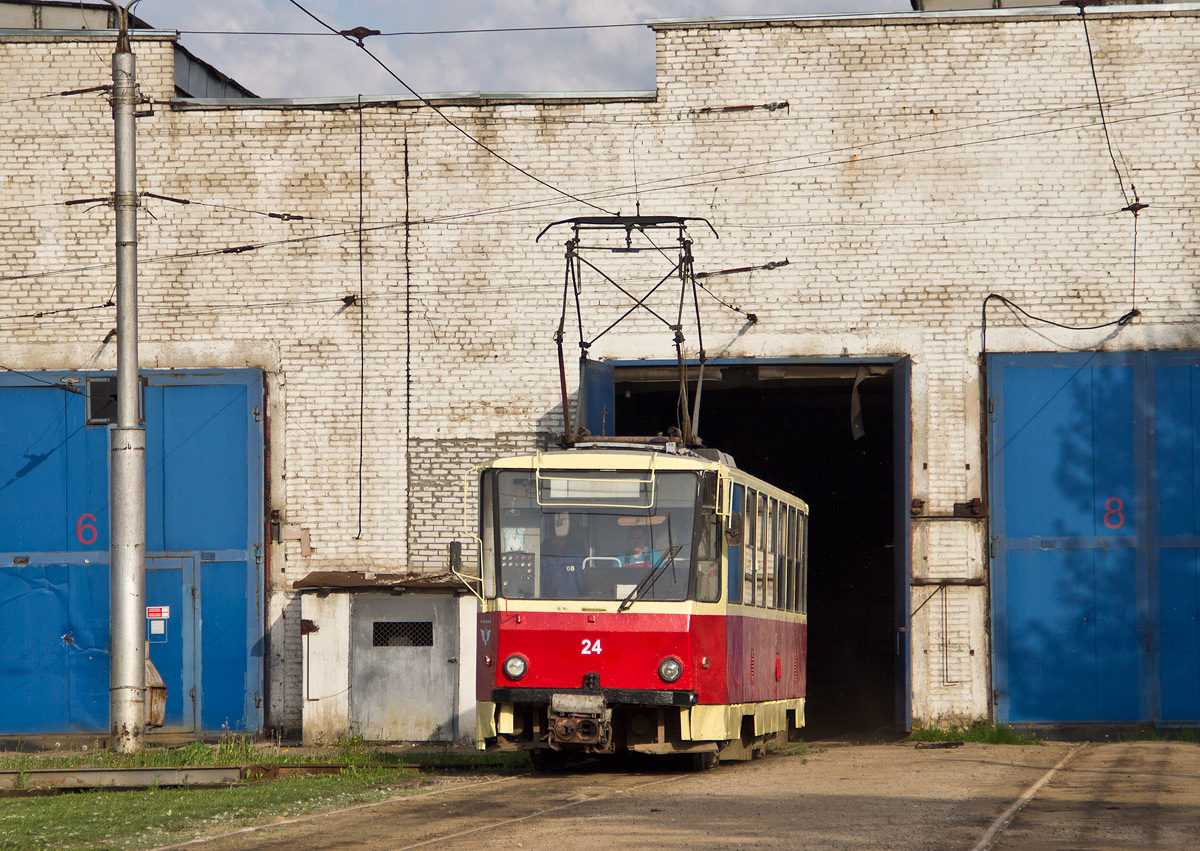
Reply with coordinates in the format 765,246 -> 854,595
157,742 -> 1200,851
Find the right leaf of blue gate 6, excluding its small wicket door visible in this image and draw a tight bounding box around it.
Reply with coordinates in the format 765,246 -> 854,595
145,371 -> 263,731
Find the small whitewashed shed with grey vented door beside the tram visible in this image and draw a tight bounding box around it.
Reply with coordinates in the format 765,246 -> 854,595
294,573 -> 476,744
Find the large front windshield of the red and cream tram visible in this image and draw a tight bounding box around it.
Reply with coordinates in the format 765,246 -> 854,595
485,469 -> 716,601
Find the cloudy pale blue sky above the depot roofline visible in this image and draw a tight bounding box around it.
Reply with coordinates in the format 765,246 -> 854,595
131,0 -> 912,98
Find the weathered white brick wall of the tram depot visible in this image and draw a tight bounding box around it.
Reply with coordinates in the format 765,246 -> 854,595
0,7 -> 1200,727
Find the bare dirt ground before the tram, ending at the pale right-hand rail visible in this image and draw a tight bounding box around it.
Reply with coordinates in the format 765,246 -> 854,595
154,744 -> 1099,851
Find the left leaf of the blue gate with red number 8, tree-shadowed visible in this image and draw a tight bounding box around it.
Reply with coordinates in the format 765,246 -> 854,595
996,355 -> 1142,721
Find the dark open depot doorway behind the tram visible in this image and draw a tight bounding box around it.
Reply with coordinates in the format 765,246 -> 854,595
614,362 -> 907,738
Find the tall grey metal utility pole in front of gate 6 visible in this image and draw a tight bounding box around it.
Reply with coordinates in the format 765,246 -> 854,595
108,0 -> 146,753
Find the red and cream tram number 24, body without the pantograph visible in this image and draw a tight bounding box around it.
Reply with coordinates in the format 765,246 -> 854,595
460,438 -> 808,767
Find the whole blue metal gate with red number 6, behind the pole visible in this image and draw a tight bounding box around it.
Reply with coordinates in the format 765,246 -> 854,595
0,370 -> 263,733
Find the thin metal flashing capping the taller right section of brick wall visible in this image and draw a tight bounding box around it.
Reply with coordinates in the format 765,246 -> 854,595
646,2 -> 1200,30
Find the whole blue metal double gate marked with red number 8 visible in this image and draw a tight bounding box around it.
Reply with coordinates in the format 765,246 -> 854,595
988,353 -> 1200,724
